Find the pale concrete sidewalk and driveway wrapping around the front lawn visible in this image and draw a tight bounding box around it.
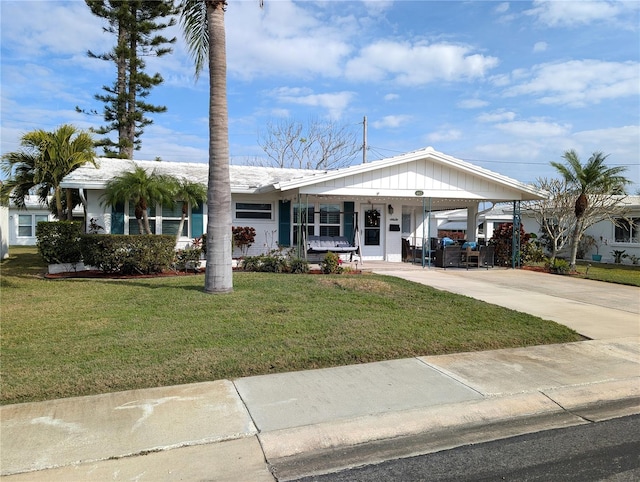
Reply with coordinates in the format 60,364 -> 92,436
0,263 -> 640,482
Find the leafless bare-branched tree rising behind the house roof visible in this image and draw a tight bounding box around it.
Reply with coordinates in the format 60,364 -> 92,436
252,119 -> 361,170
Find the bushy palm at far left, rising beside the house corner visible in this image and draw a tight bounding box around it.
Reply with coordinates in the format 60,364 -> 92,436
2,124 -> 95,219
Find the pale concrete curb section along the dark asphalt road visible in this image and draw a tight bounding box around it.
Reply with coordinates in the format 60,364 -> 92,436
258,378 -> 640,481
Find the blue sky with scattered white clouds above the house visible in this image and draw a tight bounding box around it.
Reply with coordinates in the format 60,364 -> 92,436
0,0 -> 640,193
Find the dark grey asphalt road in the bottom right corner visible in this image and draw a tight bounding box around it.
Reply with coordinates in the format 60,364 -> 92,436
298,415 -> 640,482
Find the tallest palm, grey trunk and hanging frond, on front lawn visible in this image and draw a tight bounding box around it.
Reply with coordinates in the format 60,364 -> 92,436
181,0 -> 233,293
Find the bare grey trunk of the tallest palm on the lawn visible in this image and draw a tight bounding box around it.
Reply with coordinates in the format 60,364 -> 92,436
204,0 -> 233,293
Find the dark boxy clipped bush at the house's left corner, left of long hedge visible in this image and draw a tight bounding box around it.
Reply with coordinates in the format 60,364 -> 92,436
36,221 -> 82,264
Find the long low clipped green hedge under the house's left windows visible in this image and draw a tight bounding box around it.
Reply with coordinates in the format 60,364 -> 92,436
80,234 -> 176,274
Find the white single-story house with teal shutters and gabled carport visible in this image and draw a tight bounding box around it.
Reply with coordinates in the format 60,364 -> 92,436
61,147 -> 544,261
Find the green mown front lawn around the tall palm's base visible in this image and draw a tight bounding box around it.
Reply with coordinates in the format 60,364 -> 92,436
0,248 -> 581,404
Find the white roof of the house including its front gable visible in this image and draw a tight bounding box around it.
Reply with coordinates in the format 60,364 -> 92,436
62,147 -> 546,202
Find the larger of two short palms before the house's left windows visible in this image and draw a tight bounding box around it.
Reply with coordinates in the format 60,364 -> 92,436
102,164 -> 175,234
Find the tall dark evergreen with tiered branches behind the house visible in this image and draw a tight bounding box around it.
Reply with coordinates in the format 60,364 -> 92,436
82,0 -> 178,159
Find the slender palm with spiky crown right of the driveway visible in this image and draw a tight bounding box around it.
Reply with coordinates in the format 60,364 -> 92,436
551,149 -> 630,270
